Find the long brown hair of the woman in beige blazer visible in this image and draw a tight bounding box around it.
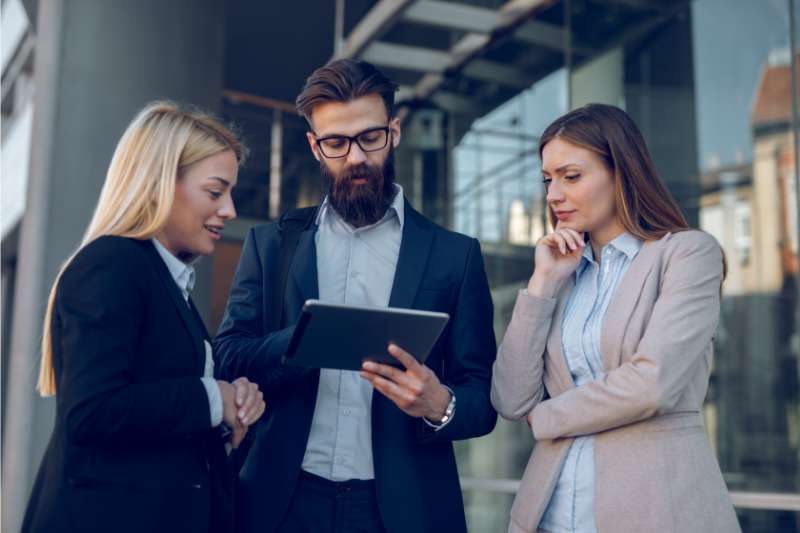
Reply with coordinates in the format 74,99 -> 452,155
539,104 -> 689,241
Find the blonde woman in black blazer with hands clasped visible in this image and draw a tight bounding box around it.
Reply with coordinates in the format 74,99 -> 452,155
22,102 -> 264,533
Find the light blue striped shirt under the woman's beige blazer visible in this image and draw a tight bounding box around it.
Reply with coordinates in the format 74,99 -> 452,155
539,233 -> 642,533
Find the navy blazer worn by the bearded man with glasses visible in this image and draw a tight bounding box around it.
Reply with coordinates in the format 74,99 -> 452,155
215,201 -> 497,533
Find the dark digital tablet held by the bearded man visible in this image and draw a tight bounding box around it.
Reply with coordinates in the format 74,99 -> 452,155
283,300 -> 450,370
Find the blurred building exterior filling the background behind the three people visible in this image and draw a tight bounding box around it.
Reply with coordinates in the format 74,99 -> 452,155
0,0 -> 800,533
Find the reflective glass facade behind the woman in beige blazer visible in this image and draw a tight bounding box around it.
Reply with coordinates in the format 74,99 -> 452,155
418,0 -> 800,532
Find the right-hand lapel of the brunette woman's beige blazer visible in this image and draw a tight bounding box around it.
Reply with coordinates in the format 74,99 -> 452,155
600,234 -> 670,372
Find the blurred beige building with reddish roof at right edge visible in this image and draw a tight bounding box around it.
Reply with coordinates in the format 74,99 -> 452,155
700,55 -> 798,296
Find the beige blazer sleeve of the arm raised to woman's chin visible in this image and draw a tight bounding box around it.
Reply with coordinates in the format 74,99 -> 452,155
491,289 -> 556,420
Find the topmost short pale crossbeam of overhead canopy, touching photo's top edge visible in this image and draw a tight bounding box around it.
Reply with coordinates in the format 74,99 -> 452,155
403,0 -> 498,33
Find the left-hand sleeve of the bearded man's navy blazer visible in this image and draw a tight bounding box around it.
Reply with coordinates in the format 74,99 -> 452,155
214,224 -> 308,393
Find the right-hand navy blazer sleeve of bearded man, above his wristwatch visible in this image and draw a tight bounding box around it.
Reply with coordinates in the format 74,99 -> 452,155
418,239 -> 497,442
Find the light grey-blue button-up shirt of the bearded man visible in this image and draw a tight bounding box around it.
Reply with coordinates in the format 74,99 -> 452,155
302,185 -> 404,481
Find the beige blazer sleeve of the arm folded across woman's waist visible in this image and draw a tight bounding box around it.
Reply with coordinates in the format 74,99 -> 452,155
530,232 -> 722,440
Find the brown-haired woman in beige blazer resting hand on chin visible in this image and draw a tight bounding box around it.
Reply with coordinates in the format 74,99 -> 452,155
491,104 -> 739,533
